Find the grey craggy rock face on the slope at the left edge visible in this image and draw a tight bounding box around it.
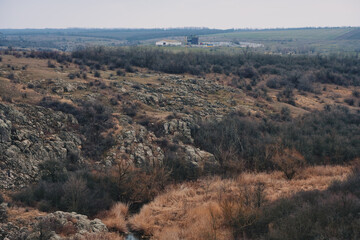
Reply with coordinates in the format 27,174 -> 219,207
0,104 -> 81,189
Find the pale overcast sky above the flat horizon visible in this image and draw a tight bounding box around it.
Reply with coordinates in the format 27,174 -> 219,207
0,0 -> 360,29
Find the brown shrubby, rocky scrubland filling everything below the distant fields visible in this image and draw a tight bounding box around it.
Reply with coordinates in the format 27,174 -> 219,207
0,47 -> 360,240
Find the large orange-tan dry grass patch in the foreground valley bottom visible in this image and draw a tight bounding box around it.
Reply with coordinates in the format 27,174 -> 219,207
129,166 -> 351,240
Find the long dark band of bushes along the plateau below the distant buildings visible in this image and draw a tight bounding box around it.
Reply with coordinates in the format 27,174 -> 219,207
72,47 -> 360,89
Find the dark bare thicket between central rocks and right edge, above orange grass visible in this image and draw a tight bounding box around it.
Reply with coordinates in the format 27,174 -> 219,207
193,107 -> 360,174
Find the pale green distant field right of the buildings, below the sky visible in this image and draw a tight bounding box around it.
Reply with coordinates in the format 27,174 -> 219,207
202,27 -> 360,53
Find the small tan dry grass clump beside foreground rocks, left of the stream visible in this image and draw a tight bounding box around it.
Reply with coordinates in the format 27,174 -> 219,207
99,203 -> 129,233
